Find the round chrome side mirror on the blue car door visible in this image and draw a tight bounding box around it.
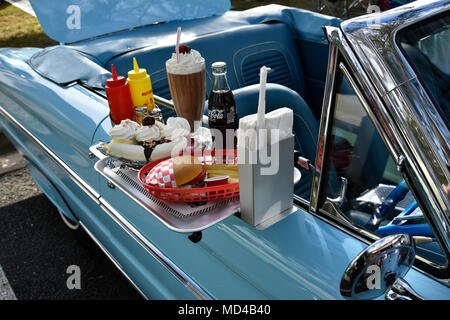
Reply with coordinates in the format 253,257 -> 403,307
340,234 -> 423,300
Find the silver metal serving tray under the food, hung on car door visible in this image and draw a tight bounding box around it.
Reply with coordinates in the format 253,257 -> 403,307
90,146 -> 239,233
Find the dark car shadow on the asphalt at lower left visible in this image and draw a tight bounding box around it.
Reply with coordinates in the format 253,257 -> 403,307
0,194 -> 141,300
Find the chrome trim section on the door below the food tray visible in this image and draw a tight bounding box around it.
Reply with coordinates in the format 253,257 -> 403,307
100,198 -> 212,300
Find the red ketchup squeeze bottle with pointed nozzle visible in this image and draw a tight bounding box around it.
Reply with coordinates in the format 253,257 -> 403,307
105,64 -> 134,124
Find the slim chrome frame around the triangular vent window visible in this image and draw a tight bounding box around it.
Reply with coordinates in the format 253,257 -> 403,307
310,27 -> 450,285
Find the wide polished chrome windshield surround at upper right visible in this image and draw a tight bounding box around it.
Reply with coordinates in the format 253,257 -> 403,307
341,0 -> 450,252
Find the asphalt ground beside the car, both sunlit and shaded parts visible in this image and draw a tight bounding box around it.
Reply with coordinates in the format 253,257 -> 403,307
0,137 -> 141,300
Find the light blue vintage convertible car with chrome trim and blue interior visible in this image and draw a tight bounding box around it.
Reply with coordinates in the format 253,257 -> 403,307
0,0 -> 450,299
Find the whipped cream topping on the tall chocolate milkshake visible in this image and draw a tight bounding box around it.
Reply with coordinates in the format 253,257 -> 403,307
166,49 -> 205,74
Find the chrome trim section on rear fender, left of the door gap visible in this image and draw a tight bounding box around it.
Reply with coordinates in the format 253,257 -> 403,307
0,106 -> 100,204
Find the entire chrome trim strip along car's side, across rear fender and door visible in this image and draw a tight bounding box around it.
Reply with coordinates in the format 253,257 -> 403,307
0,106 -> 212,300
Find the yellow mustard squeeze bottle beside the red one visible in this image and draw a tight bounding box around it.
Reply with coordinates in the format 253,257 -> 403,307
127,57 -> 155,110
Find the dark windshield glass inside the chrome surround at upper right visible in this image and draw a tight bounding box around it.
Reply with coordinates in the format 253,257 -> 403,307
398,13 -> 450,128
